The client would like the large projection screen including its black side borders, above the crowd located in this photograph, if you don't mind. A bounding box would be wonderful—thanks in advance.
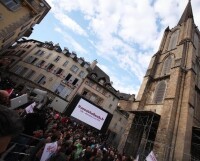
[66,95,112,132]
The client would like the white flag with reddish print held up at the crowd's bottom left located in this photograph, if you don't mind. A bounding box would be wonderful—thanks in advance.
[40,141,58,161]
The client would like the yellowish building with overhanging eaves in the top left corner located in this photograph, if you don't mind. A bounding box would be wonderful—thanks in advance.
[0,0,51,51]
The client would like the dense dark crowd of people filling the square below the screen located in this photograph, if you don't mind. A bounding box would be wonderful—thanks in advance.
[0,74,133,161]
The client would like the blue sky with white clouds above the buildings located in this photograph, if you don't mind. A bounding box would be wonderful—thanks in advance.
[29,0,200,95]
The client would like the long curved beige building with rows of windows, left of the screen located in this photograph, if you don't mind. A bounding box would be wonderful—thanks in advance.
[1,40,90,101]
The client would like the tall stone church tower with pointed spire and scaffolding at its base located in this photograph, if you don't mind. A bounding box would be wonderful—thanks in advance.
[120,1,200,161]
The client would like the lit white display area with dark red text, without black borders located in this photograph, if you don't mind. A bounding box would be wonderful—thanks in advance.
[71,98,108,130]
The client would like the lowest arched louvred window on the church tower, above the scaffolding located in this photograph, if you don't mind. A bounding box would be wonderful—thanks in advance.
[154,81,166,103]
